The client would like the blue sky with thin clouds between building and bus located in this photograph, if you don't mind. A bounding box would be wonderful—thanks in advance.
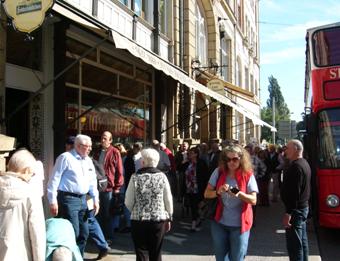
[259,0,340,121]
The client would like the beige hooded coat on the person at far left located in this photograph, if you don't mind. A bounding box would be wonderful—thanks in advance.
[0,172,46,261]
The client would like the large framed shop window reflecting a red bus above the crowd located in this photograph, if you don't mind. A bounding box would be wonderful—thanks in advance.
[65,32,153,146]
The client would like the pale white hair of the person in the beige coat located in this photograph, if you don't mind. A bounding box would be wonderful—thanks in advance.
[7,149,36,173]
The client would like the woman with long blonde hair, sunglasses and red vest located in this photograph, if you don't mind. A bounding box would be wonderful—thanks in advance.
[204,145,258,261]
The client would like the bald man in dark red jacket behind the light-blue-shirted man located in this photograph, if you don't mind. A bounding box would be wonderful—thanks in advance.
[93,131,124,240]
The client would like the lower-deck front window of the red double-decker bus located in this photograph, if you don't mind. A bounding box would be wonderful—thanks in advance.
[318,109,340,168]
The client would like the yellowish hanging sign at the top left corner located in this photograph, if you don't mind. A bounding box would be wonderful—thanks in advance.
[3,0,54,33]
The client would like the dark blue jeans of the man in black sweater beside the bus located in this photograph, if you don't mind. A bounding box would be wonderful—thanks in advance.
[286,207,309,261]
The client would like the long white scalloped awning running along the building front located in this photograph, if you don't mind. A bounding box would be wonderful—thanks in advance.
[53,3,276,131]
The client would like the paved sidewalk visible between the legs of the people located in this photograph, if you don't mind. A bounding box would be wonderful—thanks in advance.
[85,199,321,261]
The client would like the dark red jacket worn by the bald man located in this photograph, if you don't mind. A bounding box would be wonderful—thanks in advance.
[93,145,124,192]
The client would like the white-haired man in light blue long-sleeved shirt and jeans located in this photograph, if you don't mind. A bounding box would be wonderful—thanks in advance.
[47,134,99,254]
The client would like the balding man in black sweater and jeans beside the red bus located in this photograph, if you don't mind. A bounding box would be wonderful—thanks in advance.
[281,140,311,261]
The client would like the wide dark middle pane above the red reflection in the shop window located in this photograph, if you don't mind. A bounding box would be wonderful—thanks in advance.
[82,63,117,94]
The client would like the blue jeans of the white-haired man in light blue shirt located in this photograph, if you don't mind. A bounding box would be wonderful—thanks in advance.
[57,193,89,255]
